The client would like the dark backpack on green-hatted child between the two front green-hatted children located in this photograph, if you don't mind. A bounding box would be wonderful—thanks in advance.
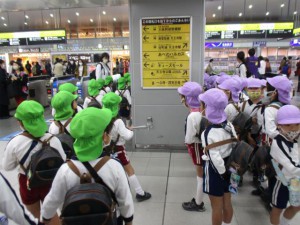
[54,118,75,159]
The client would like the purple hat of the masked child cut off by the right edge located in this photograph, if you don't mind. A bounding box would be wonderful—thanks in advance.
[276,105,300,125]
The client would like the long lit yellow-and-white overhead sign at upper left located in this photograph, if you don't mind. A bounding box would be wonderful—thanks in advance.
[0,30,67,46]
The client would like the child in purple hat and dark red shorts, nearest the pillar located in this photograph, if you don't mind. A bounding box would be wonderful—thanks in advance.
[178,82,205,212]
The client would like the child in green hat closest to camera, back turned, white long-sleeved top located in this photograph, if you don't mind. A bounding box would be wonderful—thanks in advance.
[41,107,134,225]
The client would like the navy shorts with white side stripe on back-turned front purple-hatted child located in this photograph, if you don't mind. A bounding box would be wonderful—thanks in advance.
[203,161,230,197]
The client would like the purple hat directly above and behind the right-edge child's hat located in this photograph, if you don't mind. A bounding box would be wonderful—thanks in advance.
[267,76,292,104]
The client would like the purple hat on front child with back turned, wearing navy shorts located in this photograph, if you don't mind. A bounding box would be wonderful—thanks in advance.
[198,88,228,124]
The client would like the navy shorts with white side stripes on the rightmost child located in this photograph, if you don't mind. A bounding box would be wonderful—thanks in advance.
[270,177,290,209]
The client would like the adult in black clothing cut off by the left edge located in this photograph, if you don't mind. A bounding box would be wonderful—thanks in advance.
[0,59,10,119]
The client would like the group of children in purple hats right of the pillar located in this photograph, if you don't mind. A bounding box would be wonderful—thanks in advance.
[178,73,300,225]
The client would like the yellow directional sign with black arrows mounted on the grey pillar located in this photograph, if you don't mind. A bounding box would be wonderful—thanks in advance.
[141,17,191,88]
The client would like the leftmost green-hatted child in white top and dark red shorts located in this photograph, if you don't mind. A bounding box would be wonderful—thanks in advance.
[2,101,66,224]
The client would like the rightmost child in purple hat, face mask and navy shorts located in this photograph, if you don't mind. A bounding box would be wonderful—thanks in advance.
[270,105,300,225]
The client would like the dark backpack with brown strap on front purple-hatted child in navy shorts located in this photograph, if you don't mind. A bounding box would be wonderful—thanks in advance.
[204,125,253,176]
